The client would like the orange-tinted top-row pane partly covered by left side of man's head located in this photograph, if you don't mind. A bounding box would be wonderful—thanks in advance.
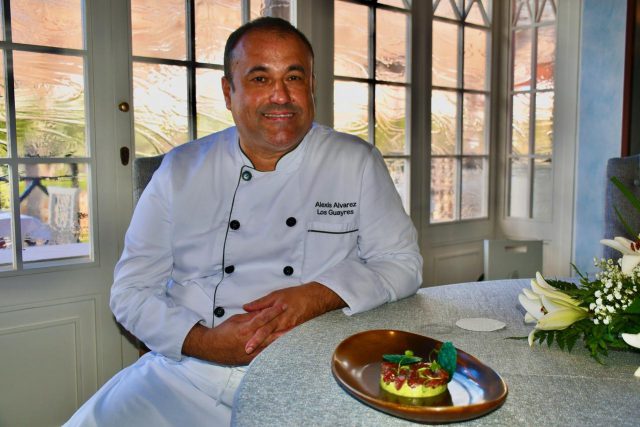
[195,0,242,64]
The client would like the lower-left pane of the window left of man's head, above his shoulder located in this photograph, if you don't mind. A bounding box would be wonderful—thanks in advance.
[133,63,189,157]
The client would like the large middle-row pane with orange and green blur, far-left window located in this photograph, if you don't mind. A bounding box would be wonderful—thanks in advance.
[13,51,88,157]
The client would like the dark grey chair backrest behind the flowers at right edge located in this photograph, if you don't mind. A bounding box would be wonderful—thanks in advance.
[602,155,640,259]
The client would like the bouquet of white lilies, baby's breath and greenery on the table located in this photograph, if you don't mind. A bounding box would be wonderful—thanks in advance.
[518,178,640,376]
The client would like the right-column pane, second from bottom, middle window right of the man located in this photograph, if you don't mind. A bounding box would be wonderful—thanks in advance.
[462,93,488,154]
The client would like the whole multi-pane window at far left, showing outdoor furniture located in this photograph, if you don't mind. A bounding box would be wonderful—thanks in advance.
[0,0,92,270]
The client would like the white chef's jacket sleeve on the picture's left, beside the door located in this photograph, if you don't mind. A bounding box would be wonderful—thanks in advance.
[110,156,203,360]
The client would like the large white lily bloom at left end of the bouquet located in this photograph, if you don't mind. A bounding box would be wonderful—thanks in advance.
[518,273,589,346]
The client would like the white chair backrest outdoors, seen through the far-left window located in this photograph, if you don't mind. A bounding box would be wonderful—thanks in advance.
[47,186,80,244]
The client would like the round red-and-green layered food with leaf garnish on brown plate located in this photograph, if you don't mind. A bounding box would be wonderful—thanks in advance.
[380,342,457,398]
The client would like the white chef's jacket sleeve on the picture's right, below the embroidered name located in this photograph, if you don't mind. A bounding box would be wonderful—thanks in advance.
[316,148,422,314]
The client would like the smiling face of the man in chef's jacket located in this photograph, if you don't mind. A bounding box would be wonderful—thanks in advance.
[222,30,315,166]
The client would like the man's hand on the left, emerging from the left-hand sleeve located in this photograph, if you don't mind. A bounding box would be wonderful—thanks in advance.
[182,303,288,365]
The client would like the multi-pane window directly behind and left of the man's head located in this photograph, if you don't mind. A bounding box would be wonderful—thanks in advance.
[131,0,290,156]
